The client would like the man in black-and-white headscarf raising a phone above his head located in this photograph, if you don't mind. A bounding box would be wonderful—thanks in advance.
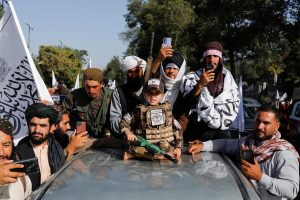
[151,47,186,108]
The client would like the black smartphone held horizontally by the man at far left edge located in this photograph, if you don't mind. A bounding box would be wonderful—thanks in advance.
[10,157,40,175]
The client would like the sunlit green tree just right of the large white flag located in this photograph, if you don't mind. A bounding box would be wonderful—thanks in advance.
[38,46,87,88]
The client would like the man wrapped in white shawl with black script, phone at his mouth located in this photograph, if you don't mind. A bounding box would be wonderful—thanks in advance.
[173,41,239,141]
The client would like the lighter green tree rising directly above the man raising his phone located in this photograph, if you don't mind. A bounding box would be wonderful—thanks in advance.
[122,0,194,60]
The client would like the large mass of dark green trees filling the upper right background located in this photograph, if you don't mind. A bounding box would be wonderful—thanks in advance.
[123,0,300,95]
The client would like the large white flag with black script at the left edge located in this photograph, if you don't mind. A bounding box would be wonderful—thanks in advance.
[0,0,53,140]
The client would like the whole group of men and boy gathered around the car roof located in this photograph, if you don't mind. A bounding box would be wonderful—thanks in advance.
[0,41,299,198]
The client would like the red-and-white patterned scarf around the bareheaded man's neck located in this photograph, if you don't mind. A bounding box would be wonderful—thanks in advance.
[245,131,300,162]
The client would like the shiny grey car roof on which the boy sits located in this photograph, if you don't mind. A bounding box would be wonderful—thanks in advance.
[29,148,261,200]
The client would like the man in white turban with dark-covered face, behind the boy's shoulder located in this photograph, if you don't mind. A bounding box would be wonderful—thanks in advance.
[109,56,146,138]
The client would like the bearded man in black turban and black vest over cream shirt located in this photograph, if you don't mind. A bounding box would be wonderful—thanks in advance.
[16,103,65,191]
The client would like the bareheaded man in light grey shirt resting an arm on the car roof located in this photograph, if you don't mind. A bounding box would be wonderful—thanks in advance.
[188,106,299,199]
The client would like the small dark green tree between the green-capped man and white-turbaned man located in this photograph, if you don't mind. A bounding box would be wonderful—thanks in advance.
[104,56,126,86]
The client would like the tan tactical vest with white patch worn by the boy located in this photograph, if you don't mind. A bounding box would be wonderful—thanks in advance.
[135,103,174,144]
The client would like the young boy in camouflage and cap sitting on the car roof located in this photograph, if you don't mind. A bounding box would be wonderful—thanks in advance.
[121,79,183,160]
